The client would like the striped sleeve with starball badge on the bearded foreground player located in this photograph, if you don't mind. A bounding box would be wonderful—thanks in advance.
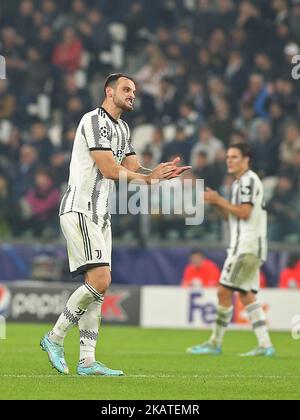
[81,115,112,152]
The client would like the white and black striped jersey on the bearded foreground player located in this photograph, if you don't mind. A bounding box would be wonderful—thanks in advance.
[60,108,135,227]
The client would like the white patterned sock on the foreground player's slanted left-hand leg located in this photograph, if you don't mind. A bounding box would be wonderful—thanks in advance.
[49,283,103,346]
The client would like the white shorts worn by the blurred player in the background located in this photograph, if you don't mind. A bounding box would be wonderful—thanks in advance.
[220,254,263,293]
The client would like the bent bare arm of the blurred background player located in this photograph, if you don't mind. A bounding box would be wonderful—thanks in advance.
[204,188,253,220]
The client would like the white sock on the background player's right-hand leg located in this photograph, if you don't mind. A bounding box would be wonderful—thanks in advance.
[246,302,272,348]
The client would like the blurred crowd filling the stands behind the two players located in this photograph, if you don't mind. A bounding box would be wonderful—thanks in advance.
[0,0,300,243]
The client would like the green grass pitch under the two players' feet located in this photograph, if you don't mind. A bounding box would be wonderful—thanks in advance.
[0,324,300,400]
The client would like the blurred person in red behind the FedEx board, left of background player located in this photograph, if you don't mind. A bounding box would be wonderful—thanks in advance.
[181,249,221,287]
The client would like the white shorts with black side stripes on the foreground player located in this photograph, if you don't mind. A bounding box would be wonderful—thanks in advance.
[60,212,112,277]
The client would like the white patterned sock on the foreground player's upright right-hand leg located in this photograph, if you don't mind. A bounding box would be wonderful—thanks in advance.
[78,301,103,367]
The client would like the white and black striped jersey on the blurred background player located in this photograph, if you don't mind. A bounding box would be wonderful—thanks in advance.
[229,171,268,261]
